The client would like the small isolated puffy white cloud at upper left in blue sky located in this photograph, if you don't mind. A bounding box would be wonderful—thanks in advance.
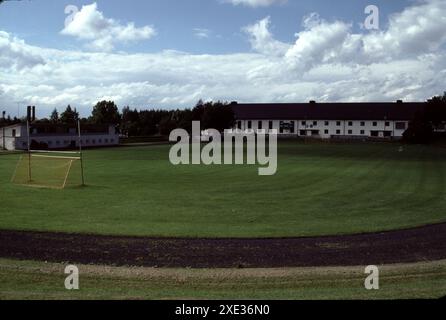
[61,3,156,51]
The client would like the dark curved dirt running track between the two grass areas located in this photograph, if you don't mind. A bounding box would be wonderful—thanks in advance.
[0,223,446,268]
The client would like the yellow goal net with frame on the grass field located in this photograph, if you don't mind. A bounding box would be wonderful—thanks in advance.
[11,151,82,189]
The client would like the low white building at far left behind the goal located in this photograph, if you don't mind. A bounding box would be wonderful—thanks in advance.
[0,123,119,151]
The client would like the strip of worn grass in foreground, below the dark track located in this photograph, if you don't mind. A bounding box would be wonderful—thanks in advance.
[0,259,446,300]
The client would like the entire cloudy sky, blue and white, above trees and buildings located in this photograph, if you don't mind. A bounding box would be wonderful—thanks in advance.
[0,0,446,116]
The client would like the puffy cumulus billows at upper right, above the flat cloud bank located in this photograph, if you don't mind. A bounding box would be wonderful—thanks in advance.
[245,0,446,72]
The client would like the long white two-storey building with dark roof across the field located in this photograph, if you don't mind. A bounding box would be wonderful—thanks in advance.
[231,100,425,139]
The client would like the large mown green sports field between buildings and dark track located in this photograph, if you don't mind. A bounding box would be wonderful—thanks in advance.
[0,142,446,237]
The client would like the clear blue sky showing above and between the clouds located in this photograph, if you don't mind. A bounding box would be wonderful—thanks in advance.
[0,0,410,53]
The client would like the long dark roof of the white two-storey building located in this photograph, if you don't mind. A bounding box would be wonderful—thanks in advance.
[231,102,425,120]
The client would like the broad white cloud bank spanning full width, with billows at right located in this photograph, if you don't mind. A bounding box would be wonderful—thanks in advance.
[0,0,446,116]
